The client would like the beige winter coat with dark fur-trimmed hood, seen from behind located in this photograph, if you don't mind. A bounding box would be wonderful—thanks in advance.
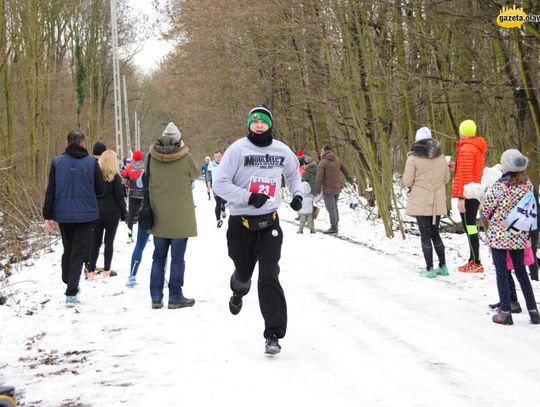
[403,139,450,219]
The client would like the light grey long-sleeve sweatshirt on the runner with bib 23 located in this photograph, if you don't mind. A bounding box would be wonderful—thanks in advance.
[212,137,303,216]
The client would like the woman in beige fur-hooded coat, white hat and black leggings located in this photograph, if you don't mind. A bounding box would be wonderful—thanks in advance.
[403,127,450,278]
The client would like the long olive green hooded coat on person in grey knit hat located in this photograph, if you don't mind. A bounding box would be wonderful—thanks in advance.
[145,136,199,239]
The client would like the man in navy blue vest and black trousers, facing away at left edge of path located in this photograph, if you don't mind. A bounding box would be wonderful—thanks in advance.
[43,131,105,307]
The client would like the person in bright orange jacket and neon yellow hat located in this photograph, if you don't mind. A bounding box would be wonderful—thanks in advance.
[452,120,488,273]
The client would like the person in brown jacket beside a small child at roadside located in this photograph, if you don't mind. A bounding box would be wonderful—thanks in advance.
[315,144,354,234]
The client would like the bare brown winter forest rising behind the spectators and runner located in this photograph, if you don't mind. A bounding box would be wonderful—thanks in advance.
[0,0,540,267]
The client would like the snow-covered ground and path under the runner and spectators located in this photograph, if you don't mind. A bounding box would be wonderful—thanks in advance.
[0,183,540,407]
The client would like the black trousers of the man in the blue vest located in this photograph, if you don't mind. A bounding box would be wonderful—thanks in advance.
[58,222,93,296]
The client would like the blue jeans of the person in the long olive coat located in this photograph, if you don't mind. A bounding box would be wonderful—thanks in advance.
[150,236,187,301]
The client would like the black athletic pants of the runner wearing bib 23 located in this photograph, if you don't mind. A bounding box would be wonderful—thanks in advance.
[227,216,287,338]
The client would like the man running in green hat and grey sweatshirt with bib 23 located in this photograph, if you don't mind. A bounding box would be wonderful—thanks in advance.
[213,105,303,354]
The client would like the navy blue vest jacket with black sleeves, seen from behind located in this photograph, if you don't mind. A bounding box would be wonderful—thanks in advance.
[43,144,104,223]
